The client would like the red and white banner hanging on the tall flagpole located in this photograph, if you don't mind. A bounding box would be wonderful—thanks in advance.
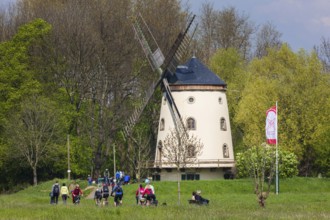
[266,106,277,144]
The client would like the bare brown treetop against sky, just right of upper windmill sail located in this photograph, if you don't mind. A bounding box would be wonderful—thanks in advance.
[197,3,255,62]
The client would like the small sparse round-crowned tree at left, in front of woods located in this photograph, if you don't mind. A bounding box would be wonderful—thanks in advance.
[7,96,60,185]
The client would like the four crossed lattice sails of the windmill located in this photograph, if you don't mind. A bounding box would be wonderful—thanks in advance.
[124,14,196,136]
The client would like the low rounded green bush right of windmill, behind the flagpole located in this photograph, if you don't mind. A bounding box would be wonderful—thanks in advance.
[235,146,298,178]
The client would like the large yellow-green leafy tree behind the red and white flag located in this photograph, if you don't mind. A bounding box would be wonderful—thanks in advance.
[234,45,330,175]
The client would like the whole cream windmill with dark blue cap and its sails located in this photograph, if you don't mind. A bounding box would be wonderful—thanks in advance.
[125,15,234,180]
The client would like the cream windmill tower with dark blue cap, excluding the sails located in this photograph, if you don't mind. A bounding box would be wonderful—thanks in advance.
[153,57,235,180]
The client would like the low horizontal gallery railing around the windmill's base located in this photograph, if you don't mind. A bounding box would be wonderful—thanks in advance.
[141,159,235,169]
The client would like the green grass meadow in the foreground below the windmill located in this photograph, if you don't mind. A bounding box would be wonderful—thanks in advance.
[0,178,330,220]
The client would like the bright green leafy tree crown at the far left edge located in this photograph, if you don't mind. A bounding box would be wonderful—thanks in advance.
[0,19,51,132]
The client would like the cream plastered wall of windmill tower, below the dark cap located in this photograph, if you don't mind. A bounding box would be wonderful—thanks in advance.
[155,88,234,167]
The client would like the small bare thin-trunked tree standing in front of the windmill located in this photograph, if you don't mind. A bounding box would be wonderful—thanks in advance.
[161,125,204,204]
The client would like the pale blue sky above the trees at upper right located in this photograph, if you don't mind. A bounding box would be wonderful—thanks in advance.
[187,0,330,51]
